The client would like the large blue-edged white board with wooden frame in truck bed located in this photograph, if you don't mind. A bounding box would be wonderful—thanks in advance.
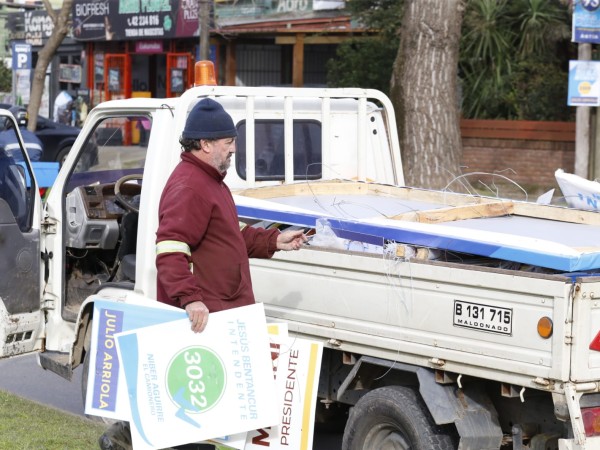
[235,183,600,272]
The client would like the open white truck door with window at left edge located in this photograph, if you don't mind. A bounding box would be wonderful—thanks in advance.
[0,110,43,358]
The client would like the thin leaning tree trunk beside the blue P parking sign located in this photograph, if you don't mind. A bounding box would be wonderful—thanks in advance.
[27,0,73,131]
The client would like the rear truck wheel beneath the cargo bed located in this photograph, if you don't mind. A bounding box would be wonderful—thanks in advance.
[342,386,457,450]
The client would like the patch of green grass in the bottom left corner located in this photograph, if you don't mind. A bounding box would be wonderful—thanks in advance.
[0,390,106,450]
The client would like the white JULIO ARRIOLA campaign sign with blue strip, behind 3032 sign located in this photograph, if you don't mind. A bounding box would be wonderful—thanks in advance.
[85,298,187,420]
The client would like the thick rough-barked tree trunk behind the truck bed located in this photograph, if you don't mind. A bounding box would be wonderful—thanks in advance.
[391,0,465,189]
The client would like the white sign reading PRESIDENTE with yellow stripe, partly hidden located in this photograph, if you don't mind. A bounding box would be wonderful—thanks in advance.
[244,337,323,450]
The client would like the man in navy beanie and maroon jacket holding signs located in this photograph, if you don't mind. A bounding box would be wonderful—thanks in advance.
[100,98,306,450]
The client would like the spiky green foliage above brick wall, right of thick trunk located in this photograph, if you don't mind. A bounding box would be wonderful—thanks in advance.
[460,0,570,120]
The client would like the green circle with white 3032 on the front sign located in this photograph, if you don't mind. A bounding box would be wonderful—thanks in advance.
[166,346,227,414]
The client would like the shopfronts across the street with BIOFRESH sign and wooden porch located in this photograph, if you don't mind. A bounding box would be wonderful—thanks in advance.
[4,0,364,117]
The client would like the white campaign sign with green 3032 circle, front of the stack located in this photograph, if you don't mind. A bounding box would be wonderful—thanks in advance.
[115,304,279,450]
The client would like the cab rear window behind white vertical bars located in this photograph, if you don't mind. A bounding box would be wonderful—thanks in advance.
[235,119,322,181]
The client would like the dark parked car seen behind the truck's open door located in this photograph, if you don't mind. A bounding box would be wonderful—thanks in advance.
[0,103,81,165]
